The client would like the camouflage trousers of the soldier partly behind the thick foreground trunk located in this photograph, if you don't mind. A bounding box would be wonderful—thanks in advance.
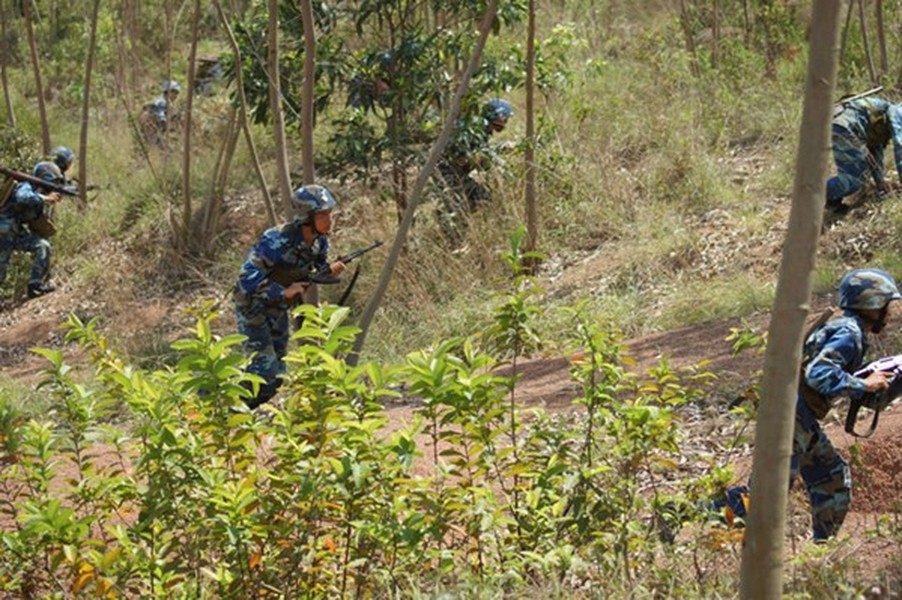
[714,398,852,541]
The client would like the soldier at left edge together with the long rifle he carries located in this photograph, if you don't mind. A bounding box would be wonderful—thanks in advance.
[0,161,77,298]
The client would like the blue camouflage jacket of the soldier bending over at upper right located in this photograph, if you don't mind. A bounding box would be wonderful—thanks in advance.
[833,97,902,184]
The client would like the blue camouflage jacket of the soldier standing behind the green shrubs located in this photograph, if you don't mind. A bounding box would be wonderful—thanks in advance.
[234,221,329,307]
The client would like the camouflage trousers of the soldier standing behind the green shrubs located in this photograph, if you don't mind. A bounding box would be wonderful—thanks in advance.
[235,301,290,402]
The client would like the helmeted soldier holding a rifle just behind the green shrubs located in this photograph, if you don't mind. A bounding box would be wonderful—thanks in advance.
[233,185,345,408]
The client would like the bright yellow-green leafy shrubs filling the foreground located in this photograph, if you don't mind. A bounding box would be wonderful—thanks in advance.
[0,302,756,598]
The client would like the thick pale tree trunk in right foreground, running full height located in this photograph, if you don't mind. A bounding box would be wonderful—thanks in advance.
[741,0,840,600]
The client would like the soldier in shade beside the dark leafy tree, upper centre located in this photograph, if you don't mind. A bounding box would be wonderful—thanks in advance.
[438,98,514,235]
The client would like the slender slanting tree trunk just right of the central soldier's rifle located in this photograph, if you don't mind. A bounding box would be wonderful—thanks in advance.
[348,0,498,365]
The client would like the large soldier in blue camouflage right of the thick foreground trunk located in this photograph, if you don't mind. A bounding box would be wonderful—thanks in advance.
[715,269,902,542]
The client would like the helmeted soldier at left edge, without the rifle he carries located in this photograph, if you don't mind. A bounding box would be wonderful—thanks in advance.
[0,162,63,298]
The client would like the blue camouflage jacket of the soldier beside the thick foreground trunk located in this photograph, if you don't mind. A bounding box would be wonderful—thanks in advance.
[802,311,868,408]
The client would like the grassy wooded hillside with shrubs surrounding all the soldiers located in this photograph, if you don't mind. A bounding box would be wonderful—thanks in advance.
[0,0,902,597]
